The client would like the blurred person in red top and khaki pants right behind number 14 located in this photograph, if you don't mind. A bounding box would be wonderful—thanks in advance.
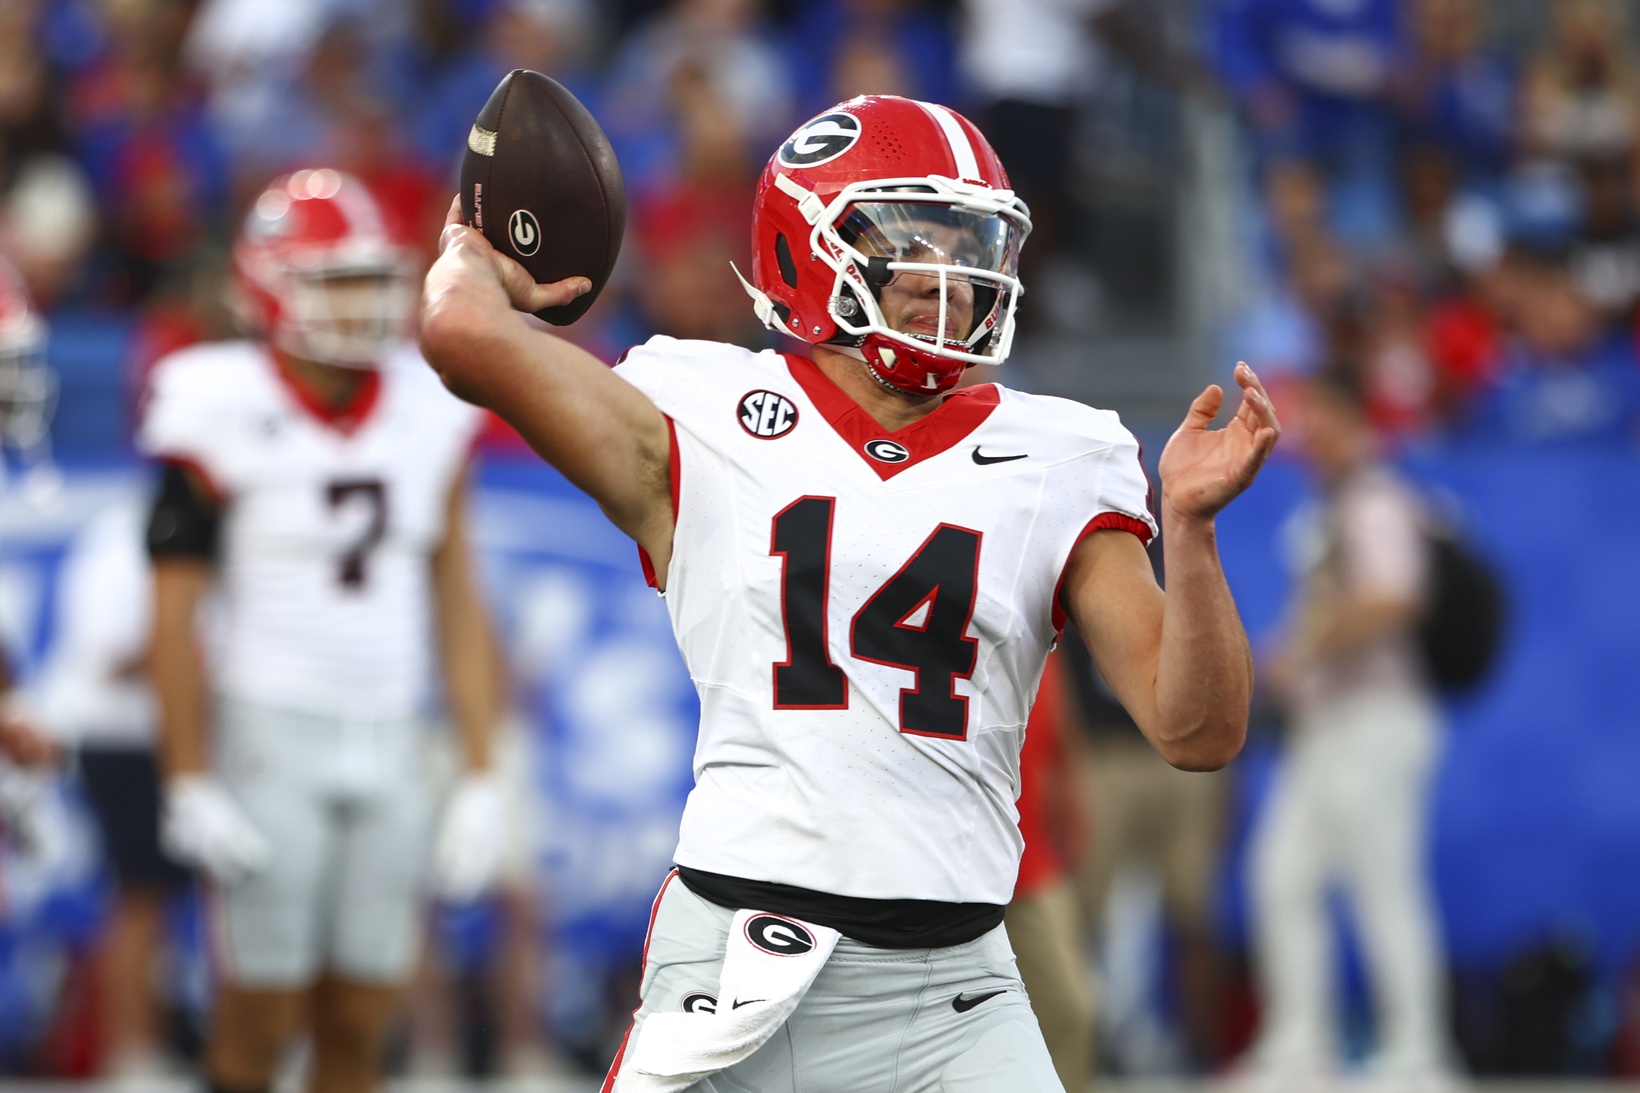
[1002,645,1095,1091]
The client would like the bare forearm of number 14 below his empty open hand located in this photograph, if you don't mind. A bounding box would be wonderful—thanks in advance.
[1151,509,1253,770]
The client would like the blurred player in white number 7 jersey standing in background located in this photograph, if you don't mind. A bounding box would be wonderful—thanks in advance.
[139,169,503,1093]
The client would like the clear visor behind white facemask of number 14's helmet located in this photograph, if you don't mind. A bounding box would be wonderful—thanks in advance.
[836,200,1023,348]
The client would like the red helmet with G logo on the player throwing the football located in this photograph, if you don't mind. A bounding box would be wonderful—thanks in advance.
[741,95,1030,394]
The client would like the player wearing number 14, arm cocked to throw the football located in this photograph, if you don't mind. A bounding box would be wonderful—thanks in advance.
[421,97,1279,1093]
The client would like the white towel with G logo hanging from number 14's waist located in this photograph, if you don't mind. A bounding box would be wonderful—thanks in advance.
[615,911,841,1093]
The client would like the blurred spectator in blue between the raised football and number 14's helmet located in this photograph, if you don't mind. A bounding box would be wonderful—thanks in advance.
[600,0,794,197]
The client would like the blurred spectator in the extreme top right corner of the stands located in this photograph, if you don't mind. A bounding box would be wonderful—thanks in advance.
[1520,0,1640,161]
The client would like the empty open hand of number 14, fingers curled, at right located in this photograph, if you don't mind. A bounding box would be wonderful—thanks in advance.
[1158,361,1281,519]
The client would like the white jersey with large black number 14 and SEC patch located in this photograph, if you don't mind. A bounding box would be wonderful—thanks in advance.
[617,338,1155,904]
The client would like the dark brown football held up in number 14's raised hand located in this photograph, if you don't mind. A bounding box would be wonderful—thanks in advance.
[461,69,626,327]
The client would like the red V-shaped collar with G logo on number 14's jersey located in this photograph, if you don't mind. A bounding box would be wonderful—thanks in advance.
[784,353,1002,481]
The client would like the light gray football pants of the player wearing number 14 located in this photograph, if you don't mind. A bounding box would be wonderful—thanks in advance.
[604,876,1064,1093]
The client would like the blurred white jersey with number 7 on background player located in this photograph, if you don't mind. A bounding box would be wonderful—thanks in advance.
[138,341,481,719]
